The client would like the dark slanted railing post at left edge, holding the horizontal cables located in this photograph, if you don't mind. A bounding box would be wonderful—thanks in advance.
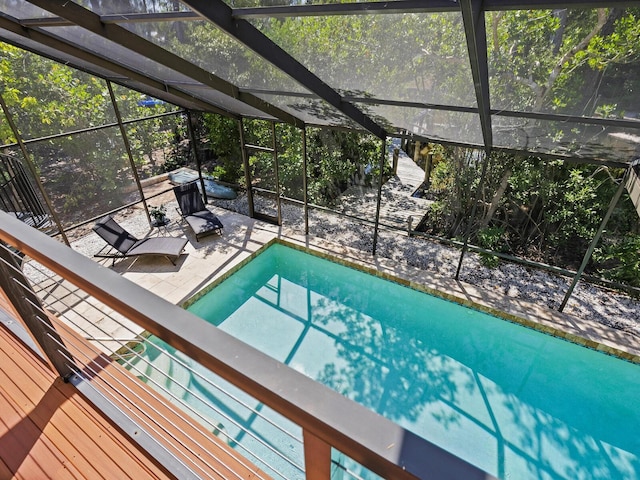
[0,244,74,381]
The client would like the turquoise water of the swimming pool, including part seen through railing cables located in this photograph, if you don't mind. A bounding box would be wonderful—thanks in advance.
[127,244,640,480]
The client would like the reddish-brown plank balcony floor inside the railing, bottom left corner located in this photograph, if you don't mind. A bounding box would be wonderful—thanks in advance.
[0,318,173,480]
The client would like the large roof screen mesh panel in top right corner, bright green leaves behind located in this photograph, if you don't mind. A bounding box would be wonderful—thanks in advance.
[485,8,640,122]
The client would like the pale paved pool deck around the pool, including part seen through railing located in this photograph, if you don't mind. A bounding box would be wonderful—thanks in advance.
[23,195,640,363]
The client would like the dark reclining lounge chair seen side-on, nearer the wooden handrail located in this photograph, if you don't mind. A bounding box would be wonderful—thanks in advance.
[93,215,188,265]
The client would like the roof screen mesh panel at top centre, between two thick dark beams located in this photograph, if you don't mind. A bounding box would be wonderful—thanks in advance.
[252,13,476,107]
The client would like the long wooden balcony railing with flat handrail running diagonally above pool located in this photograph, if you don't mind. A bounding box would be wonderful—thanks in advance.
[0,212,492,480]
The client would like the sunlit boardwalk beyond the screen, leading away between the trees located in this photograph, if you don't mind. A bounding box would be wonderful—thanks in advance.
[338,150,432,230]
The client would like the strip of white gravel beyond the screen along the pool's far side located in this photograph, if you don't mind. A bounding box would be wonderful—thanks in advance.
[204,191,640,336]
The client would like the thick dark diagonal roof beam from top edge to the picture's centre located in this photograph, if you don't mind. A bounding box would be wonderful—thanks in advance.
[183,0,386,139]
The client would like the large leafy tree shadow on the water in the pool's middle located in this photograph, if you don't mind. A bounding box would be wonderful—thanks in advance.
[314,299,473,423]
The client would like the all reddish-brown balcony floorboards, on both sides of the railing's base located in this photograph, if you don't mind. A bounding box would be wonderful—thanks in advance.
[0,298,269,480]
